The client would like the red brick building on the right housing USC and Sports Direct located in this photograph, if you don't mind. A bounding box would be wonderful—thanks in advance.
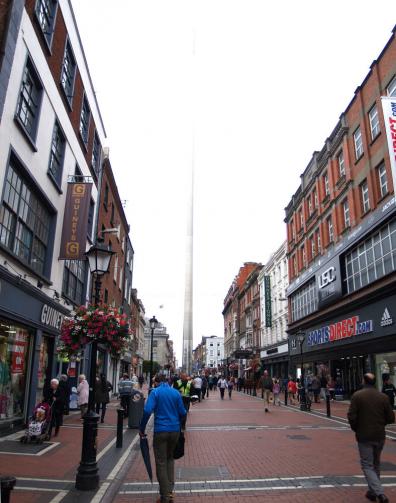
[285,24,396,394]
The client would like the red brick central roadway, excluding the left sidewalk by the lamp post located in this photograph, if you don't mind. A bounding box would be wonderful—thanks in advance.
[114,392,396,503]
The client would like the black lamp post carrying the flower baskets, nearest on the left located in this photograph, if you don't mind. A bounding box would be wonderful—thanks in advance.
[76,238,114,491]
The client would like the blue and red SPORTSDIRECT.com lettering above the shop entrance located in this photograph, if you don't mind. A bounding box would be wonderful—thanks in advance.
[307,316,374,346]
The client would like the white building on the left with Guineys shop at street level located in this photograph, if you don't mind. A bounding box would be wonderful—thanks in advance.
[0,0,106,430]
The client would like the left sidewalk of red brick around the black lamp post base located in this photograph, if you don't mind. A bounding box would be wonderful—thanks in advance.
[0,390,147,503]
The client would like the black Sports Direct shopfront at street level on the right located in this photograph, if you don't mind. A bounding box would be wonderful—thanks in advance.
[290,293,396,397]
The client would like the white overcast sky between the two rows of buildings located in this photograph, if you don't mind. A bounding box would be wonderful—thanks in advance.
[72,0,395,364]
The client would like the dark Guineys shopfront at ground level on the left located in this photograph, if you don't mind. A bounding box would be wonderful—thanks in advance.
[0,266,69,434]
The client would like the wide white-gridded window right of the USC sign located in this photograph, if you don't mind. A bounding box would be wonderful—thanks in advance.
[344,218,396,293]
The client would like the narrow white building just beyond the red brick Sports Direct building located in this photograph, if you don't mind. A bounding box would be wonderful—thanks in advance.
[258,242,289,377]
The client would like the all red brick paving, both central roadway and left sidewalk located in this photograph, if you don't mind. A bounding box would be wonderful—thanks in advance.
[0,392,396,503]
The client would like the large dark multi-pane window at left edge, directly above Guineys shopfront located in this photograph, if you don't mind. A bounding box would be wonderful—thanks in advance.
[0,157,53,275]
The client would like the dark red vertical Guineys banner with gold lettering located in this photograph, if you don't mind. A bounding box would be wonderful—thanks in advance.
[59,183,92,260]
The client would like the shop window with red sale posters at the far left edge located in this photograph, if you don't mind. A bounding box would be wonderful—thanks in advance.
[0,320,30,420]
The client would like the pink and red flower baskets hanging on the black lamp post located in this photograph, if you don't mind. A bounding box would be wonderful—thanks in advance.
[57,305,131,357]
